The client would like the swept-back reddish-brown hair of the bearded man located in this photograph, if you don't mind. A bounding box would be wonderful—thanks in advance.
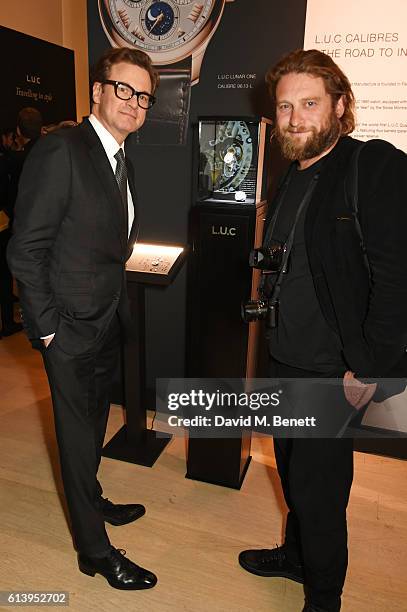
[266,49,355,134]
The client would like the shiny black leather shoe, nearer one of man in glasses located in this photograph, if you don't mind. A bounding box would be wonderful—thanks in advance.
[78,548,157,591]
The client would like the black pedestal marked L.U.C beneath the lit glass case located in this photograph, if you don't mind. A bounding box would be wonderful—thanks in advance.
[186,203,265,489]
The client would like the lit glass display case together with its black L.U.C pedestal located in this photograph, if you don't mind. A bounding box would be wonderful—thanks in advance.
[187,117,271,489]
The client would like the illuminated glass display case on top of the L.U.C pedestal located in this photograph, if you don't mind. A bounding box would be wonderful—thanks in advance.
[198,117,271,205]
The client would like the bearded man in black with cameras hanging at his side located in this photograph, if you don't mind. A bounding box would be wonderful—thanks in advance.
[239,50,407,612]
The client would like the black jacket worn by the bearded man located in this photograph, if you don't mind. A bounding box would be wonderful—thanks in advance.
[268,137,407,377]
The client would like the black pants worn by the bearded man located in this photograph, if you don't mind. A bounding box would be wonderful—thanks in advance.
[271,361,353,610]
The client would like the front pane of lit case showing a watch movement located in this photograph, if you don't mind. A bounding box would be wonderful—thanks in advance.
[199,120,258,202]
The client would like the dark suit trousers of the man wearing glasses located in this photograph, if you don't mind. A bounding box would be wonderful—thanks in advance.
[42,314,120,556]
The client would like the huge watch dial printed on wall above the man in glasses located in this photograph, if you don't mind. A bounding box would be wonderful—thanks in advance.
[103,0,219,54]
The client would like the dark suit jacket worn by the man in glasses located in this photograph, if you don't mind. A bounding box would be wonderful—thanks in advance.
[8,120,137,355]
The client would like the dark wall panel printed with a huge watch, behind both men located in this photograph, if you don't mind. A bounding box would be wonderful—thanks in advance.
[88,0,306,406]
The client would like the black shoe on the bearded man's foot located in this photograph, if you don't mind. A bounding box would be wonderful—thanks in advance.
[239,545,304,584]
